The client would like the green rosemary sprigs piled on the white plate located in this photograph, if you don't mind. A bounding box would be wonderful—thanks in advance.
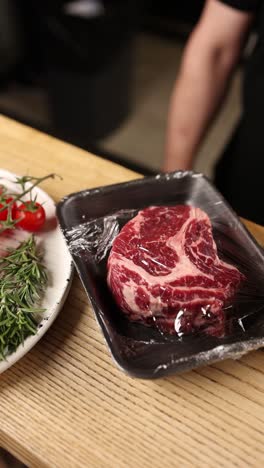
[0,236,47,360]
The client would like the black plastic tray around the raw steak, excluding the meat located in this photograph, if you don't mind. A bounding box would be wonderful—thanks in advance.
[57,172,264,378]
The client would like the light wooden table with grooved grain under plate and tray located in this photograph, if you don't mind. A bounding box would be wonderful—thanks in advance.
[0,117,264,468]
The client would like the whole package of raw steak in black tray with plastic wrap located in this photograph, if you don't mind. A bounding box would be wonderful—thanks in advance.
[58,172,264,378]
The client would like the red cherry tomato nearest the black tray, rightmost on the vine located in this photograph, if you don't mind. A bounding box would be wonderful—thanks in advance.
[13,200,46,232]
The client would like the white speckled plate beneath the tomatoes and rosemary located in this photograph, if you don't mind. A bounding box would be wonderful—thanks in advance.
[0,169,73,374]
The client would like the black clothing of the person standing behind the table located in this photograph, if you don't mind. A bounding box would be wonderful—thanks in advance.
[215,0,264,224]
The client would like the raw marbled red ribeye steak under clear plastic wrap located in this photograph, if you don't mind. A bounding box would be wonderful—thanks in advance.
[107,205,243,336]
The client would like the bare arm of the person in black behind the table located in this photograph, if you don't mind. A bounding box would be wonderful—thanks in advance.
[163,0,252,171]
